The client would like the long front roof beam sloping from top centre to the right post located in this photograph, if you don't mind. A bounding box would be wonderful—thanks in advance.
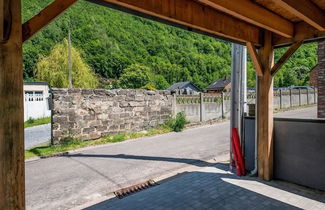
[88,0,260,46]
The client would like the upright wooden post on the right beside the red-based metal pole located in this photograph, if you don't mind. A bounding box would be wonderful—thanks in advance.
[257,31,274,180]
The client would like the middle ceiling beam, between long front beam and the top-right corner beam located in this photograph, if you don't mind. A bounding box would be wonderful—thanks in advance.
[198,0,293,38]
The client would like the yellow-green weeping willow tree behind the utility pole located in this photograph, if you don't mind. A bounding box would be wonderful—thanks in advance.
[36,40,98,88]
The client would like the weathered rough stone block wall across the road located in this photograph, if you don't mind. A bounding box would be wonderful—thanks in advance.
[52,89,173,144]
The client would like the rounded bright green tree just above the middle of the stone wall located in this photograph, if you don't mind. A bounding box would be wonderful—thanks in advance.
[118,64,151,89]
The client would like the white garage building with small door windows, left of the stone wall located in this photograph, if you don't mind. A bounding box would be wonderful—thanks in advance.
[24,82,51,121]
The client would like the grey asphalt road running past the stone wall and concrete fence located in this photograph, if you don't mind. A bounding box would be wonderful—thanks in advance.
[26,107,315,209]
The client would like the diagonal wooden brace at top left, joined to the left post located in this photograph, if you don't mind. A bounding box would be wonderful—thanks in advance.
[23,0,78,42]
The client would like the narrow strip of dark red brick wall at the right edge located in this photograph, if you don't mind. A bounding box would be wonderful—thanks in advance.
[317,41,325,118]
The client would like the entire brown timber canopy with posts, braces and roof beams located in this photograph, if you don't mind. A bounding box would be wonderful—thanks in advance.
[0,0,325,209]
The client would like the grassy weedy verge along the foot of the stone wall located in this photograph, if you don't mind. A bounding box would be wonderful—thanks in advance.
[25,125,172,159]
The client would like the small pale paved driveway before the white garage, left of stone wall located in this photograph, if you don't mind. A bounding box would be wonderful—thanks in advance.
[25,124,51,149]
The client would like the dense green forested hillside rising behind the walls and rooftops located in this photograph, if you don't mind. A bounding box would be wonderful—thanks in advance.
[23,0,316,88]
